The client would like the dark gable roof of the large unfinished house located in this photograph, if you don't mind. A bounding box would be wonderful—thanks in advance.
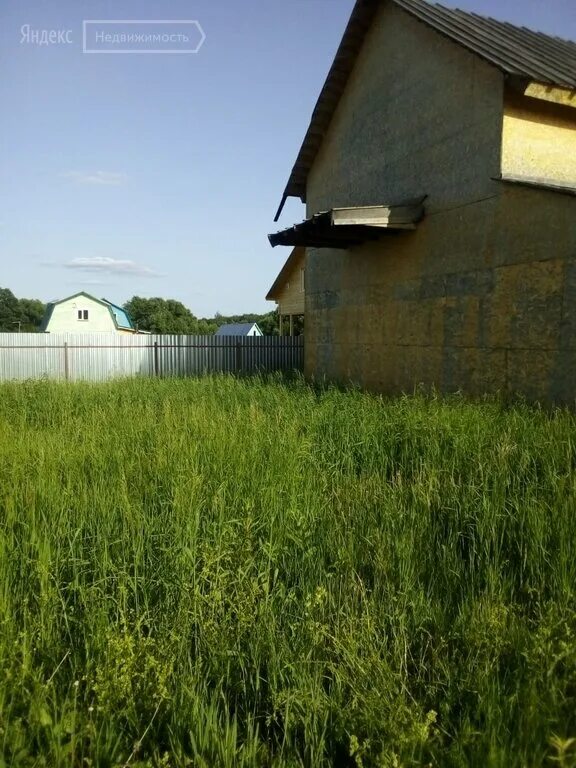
[274,0,576,221]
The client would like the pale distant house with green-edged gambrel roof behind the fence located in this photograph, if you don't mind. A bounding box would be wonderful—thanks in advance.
[41,291,143,334]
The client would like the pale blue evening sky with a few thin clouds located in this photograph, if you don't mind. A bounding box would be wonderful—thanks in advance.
[0,0,576,317]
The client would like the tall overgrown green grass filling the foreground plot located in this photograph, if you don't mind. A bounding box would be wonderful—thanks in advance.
[0,377,576,768]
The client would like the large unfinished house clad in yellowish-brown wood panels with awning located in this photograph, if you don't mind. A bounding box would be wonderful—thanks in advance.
[270,0,576,403]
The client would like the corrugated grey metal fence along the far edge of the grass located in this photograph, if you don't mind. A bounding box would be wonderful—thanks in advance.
[0,333,304,381]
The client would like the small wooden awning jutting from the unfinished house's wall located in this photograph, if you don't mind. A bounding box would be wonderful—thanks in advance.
[268,197,425,248]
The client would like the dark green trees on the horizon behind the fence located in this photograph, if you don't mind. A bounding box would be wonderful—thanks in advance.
[0,288,278,336]
